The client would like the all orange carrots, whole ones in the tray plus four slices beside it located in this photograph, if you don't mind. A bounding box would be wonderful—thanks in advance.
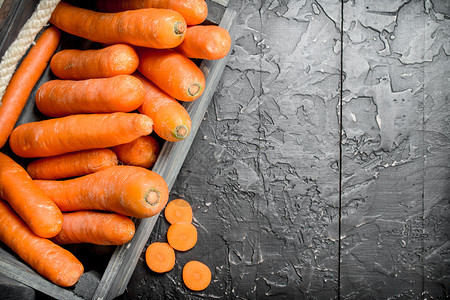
[0,0,231,290]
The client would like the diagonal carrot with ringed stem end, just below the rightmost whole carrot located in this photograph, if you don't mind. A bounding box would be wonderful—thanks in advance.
[137,48,205,101]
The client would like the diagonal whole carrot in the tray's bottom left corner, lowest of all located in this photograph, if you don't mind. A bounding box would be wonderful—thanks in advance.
[0,200,84,287]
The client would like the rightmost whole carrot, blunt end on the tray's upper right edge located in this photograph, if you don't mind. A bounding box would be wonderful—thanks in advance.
[175,25,231,60]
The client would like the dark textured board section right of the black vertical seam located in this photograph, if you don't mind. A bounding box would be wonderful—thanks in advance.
[341,0,450,299]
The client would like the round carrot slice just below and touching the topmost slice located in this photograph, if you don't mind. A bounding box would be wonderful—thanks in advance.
[167,223,197,251]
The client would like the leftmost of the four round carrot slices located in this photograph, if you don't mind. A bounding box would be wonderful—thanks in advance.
[145,242,175,273]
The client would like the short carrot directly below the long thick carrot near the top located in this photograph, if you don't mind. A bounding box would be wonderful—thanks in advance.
[50,44,139,80]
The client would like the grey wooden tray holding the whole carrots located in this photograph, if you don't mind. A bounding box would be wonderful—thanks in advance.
[0,0,236,299]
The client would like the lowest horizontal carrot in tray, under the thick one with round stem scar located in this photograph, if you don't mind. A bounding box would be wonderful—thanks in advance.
[52,211,135,245]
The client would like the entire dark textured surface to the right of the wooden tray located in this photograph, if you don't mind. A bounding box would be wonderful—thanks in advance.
[121,0,450,299]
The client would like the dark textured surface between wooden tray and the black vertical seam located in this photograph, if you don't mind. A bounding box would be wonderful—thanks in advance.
[121,1,340,299]
